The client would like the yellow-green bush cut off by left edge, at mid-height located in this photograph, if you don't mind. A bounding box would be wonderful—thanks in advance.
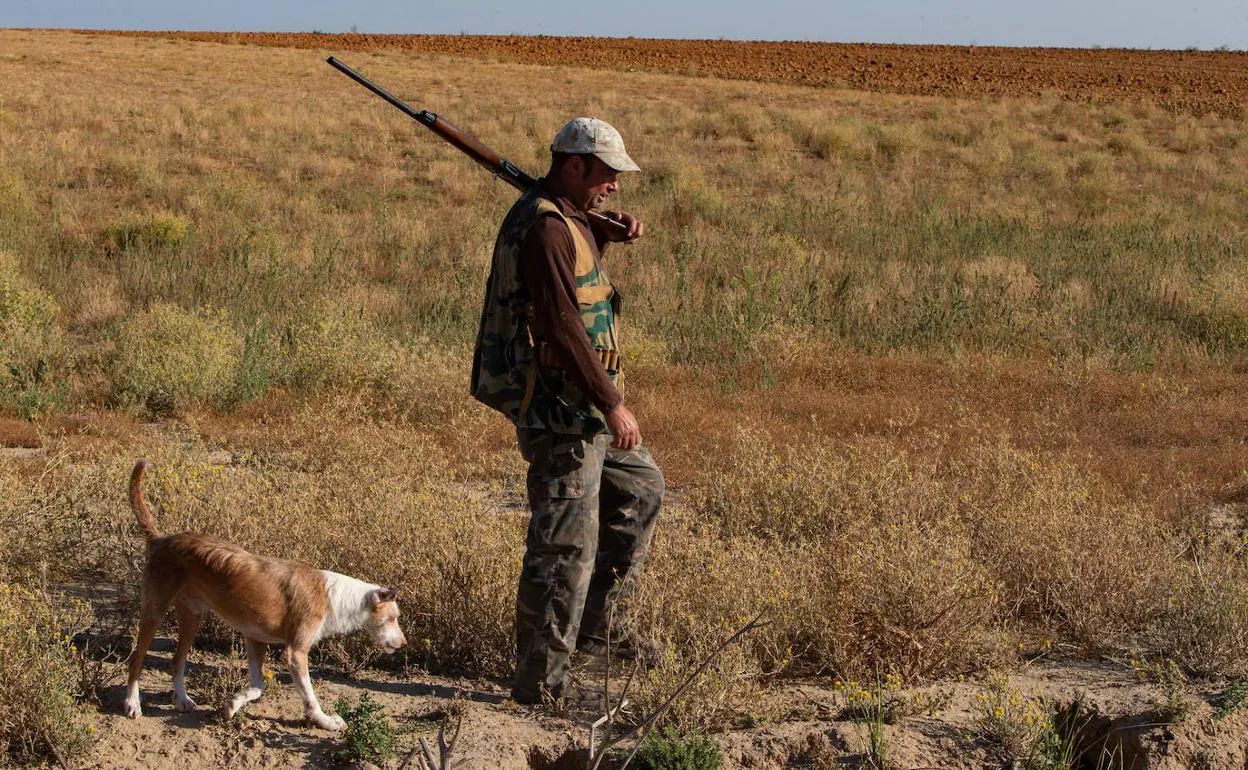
[0,251,71,418]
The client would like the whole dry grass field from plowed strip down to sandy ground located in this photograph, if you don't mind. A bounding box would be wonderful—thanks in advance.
[0,31,1248,738]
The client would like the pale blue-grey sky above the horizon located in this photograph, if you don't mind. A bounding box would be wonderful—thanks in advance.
[0,0,1248,50]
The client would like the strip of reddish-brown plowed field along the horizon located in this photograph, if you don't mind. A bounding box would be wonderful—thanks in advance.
[80,31,1248,115]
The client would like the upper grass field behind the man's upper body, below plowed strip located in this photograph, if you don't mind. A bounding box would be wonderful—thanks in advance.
[0,32,1248,389]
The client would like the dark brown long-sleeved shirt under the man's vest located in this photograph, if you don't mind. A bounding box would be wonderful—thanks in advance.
[519,180,622,414]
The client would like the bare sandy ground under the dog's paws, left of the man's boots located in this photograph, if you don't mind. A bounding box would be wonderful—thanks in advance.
[85,639,577,769]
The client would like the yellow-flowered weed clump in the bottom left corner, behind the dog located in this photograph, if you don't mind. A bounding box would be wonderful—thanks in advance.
[0,582,95,768]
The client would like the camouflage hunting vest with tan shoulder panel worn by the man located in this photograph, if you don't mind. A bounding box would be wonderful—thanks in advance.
[472,190,619,436]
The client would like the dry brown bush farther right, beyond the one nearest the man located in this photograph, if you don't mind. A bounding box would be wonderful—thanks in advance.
[953,443,1183,651]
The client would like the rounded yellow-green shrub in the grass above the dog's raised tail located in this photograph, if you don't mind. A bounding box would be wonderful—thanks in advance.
[111,305,241,414]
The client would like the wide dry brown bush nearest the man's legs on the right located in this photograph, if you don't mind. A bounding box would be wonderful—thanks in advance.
[681,432,1002,676]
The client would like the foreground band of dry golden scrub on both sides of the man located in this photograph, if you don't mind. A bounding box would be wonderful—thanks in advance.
[0,416,1248,726]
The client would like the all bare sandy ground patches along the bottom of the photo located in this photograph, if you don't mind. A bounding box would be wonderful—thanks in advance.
[85,639,1248,770]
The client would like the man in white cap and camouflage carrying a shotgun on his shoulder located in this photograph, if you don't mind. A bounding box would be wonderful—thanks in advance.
[472,117,663,703]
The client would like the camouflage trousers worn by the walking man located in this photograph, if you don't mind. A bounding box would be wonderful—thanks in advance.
[512,428,663,703]
